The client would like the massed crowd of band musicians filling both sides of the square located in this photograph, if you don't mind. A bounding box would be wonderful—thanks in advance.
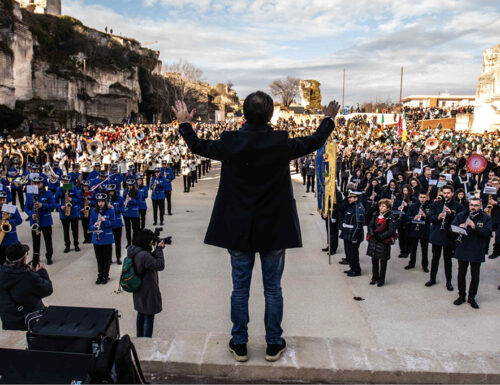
[0,109,500,335]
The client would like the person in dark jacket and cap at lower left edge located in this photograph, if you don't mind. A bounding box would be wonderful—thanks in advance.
[0,243,52,330]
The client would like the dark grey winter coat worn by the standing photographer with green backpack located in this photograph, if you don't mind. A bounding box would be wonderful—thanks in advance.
[127,245,165,315]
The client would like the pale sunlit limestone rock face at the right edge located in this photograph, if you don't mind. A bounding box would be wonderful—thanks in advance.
[472,44,500,132]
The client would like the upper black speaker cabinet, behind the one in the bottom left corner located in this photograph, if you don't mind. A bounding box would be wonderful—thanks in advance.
[26,306,120,354]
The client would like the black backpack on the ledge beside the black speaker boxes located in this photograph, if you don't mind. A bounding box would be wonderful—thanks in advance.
[90,334,149,384]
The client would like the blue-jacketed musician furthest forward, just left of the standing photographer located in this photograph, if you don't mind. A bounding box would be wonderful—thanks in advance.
[90,193,115,285]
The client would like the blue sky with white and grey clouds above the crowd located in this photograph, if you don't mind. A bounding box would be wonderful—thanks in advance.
[62,0,500,105]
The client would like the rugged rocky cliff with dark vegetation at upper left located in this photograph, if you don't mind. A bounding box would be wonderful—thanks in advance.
[0,0,162,128]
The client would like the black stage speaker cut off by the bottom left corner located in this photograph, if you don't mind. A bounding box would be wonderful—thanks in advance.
[0,349,94,384]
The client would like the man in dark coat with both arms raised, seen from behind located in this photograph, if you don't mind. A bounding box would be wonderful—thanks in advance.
[173,91,339,361]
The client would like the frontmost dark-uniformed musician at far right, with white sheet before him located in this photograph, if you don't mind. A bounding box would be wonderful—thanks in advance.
[452,197,492,309]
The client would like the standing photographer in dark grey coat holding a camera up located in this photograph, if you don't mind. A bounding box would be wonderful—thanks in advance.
[127,229,170,338]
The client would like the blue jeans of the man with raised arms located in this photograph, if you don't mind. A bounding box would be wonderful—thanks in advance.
[228,250,285,344]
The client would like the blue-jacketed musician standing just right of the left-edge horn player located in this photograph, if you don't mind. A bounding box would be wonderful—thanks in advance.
[24,176,56,265]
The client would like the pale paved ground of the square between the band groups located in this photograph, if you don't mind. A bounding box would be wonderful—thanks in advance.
[6,163,500,351]
